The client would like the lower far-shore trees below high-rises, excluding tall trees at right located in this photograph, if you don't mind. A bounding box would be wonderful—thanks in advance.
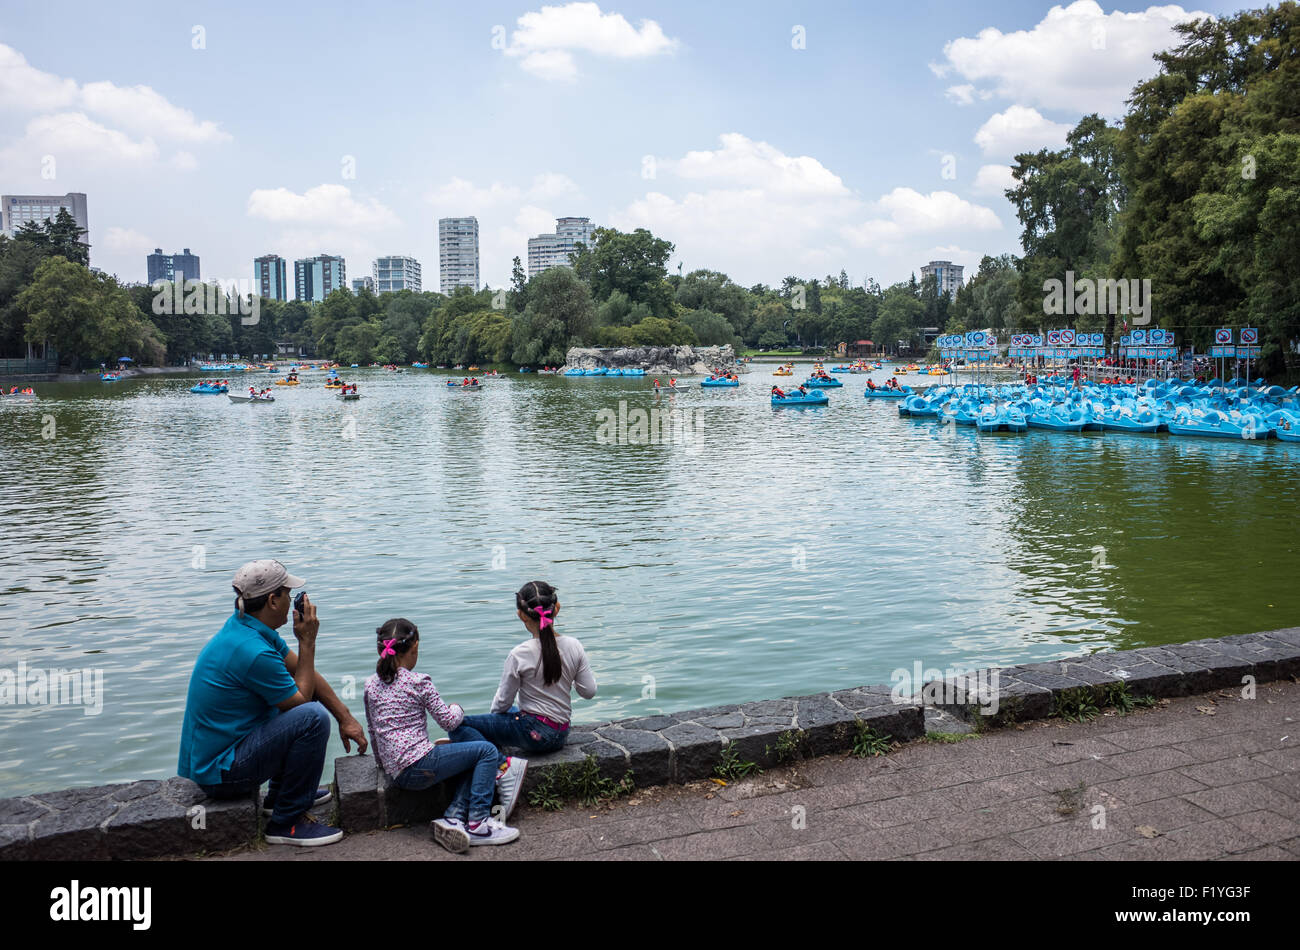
[0,212,949,366]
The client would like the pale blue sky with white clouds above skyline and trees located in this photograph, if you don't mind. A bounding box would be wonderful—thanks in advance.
[0,0,1236,290]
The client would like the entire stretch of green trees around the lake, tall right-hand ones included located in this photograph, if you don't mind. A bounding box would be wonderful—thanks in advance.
[0,7,1300,374]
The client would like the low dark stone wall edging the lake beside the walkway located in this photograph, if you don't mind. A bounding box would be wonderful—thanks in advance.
[0,628,1300,860]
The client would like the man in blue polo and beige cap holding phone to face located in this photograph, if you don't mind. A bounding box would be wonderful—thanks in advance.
[177,560,367,846]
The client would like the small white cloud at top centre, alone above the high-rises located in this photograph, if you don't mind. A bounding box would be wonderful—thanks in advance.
[506,3,680,79]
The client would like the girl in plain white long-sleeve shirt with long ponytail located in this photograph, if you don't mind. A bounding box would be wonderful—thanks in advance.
[447,581,595,754]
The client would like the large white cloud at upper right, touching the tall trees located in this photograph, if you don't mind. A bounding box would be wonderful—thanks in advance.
[931,0,1210,117]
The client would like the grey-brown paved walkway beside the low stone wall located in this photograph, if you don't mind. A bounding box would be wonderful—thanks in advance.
[208,681,1300,862]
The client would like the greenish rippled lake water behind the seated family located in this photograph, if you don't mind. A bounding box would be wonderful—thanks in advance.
[0,366,1300,795]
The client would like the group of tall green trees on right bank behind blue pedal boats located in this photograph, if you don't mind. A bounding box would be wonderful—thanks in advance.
[946,3,1300,376]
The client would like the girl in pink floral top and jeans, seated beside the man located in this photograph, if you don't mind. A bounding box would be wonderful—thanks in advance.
[365,617,521,853]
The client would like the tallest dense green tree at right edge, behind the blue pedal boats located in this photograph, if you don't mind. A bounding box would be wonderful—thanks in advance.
[1118,3,1300,373]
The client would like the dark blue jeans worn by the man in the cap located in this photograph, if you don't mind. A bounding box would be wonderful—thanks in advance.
[199,703,330,825]
